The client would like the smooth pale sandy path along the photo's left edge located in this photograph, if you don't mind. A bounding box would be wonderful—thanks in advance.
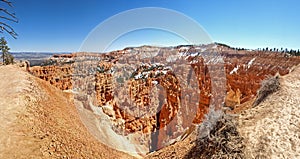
[0,66,40,158]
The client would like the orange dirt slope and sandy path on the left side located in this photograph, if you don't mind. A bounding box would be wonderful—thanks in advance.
[0,66,132,158]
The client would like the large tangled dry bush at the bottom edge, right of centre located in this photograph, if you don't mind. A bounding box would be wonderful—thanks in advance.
[184,111,244,159]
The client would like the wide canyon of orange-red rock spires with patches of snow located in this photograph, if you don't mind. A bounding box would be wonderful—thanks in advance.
[29,44,300,152]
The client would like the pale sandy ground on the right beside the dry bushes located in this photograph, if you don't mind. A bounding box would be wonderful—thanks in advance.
[239,66,300,158]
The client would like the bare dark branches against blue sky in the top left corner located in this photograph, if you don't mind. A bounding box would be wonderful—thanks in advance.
[0,0,18,39]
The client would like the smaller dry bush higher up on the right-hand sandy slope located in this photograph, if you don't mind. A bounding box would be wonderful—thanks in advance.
[253,75,280,107]
